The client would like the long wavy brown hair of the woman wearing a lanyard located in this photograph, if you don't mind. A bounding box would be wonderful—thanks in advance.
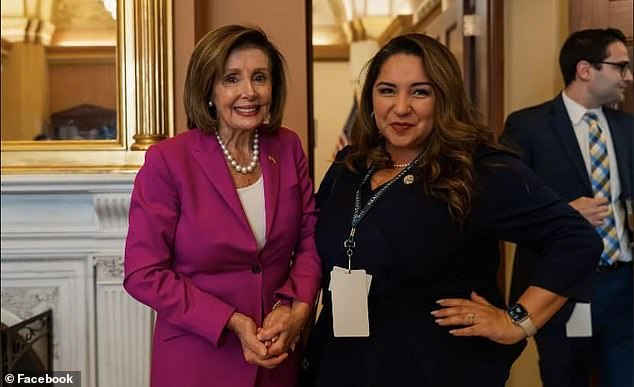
[345,33,503,223]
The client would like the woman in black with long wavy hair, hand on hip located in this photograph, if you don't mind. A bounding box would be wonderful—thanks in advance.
[304,34,602,387]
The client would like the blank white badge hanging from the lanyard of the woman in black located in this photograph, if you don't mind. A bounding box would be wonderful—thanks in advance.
[328,266,372,337]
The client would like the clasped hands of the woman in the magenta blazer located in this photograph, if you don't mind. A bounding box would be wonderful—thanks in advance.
[227,301,310,369]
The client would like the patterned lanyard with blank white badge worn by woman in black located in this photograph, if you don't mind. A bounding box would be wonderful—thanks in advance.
[328,153,422,337]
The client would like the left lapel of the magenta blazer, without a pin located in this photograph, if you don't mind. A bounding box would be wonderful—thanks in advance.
[193,129,251,231]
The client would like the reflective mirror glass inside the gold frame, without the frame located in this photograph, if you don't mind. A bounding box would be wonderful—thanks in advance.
[1,0,121,141]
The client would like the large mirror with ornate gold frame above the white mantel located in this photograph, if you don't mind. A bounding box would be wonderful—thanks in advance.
[2,0,173,174]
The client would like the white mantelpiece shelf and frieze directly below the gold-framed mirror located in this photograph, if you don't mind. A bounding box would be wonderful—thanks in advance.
[0,174,134,249]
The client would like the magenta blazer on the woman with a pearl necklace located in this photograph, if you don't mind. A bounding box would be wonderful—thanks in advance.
[124,128,321,387]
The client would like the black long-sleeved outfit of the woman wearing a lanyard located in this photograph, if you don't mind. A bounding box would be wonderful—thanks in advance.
[309,148,602,387]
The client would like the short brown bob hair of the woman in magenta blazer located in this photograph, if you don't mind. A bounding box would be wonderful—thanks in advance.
[183,25,286,133]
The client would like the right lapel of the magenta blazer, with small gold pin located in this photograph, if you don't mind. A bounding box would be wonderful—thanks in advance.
[260,133,281,239]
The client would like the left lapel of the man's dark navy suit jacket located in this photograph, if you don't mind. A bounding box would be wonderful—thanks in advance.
[549,95,593,196]
